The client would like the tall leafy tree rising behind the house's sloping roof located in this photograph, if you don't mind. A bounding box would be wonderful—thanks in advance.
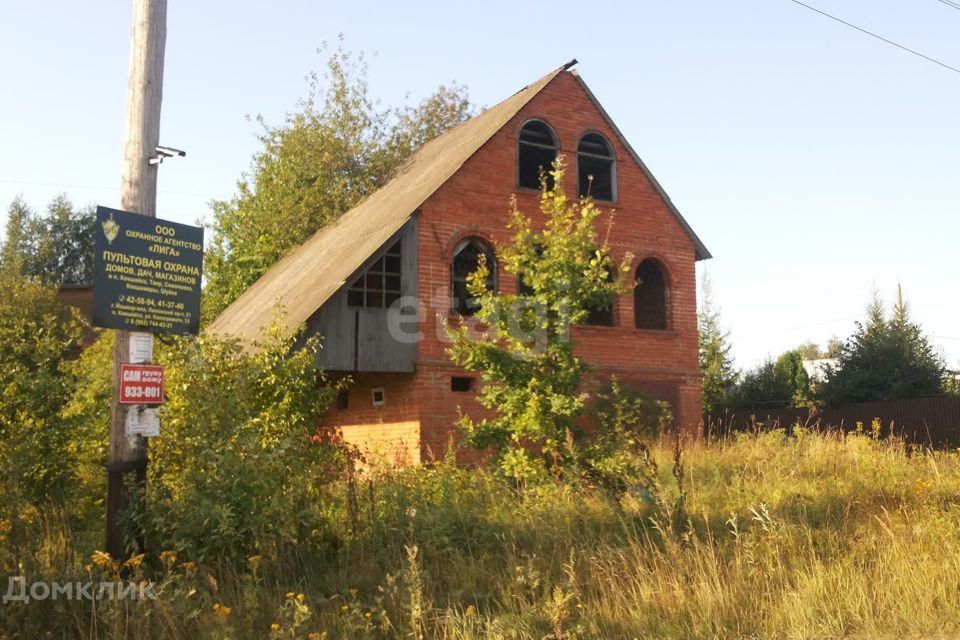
[204,43,470,319]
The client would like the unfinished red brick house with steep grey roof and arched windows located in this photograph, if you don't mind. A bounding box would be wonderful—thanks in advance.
[209,61,710,461]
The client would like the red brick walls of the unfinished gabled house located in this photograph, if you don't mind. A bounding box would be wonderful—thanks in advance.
[322,73,700,457]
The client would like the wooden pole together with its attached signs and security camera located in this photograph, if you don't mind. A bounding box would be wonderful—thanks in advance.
[92,0,203,559]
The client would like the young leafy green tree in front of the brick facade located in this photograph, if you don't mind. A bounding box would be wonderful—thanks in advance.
[449,160,629,478]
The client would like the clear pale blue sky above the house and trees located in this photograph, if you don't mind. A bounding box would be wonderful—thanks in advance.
[0,0,960,368]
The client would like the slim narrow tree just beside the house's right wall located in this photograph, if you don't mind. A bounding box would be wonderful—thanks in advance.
[697,272,738,413]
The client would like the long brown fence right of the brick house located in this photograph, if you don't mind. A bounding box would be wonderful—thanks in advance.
[704,396,960,448]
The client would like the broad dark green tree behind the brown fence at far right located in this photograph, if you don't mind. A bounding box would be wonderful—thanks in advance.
[820,290,946,405]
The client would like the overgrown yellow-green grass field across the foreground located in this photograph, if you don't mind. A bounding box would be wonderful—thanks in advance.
[0,424,960,640]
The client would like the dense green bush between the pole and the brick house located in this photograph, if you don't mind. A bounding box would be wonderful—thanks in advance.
[136,324,345,560]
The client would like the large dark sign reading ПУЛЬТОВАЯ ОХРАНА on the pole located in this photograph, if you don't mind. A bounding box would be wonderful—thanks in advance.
[93,207,203,334]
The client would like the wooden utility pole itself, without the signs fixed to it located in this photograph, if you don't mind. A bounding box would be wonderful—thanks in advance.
[107,0,167,559]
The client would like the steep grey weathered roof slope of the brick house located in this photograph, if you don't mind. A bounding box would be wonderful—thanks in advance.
[207,61,575,342]
